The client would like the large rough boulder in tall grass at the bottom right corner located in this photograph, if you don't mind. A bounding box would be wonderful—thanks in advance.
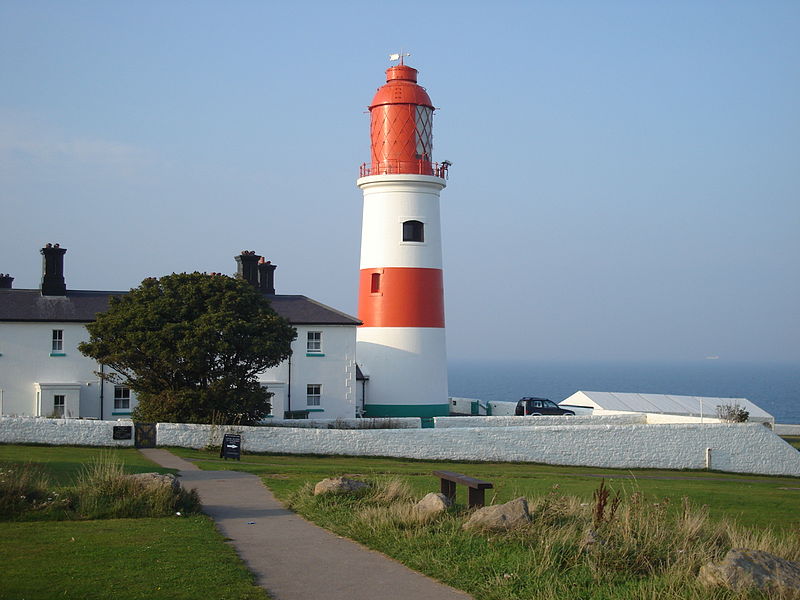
[697,548,800,598]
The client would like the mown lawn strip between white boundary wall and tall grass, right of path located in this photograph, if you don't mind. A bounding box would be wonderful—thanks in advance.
[171,448,800,529]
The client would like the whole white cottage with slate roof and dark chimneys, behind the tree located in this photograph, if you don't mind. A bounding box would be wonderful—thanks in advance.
[0,244,360,420]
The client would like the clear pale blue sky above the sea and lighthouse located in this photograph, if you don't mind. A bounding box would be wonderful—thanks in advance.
[0,0,800,362]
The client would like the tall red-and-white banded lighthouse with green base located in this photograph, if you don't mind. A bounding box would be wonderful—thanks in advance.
[356,55,449,417]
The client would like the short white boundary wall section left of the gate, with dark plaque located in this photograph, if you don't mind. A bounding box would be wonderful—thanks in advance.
[0,417,133,446]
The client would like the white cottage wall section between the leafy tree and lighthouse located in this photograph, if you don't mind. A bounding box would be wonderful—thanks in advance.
[259,325,356,419]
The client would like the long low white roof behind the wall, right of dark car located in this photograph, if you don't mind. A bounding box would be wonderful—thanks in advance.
[560,391,774,421]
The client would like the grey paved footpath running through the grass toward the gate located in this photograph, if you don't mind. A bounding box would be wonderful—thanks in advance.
[141,449,470,600]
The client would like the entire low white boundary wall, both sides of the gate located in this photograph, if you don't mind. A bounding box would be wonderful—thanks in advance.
[0,417,800,477]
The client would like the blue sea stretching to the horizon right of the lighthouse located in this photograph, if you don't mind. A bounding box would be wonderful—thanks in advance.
[448,360,800,424]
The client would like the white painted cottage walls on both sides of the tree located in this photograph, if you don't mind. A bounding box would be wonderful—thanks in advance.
[0,324,356,420]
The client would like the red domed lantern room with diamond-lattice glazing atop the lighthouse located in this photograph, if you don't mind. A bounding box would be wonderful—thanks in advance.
[362,63,443,176]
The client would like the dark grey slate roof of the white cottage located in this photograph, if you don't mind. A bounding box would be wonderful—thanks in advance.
[0,289,361,325]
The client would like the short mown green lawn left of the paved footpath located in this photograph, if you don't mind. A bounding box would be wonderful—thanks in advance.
[0,445,268,600]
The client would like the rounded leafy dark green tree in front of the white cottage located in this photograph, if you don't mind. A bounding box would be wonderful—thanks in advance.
[78,273,297,425]
